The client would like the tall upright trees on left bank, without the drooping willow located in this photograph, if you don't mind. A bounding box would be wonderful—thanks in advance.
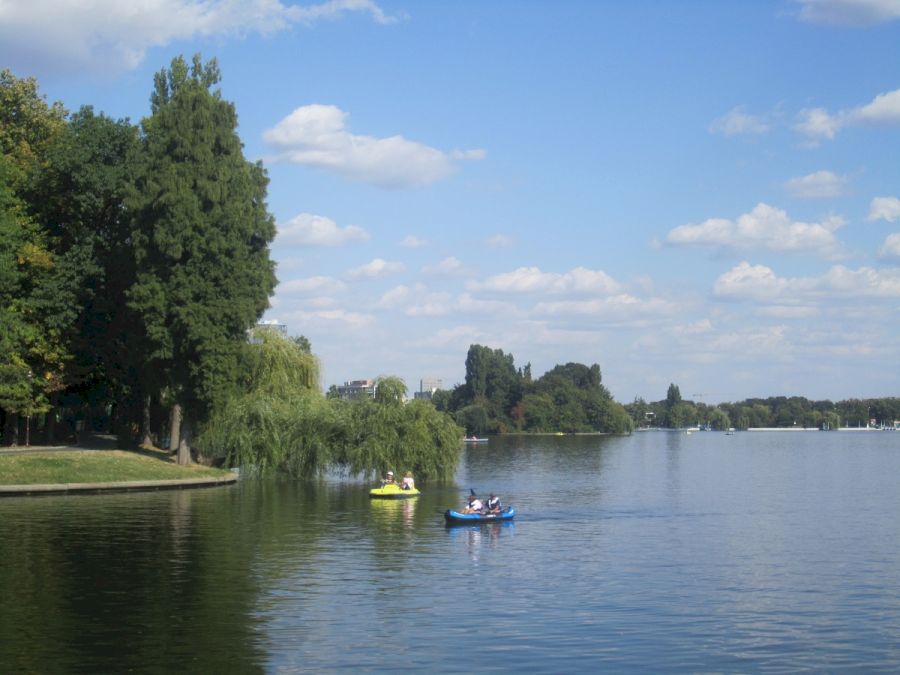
[0,56,275,462]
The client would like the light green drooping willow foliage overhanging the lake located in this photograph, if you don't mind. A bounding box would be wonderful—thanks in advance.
[196,329,462,481]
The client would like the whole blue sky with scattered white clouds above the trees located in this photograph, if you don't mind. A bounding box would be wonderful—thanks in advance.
[0,0,900,403]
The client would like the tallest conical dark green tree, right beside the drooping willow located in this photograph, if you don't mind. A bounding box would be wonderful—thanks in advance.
[129,55,276,463]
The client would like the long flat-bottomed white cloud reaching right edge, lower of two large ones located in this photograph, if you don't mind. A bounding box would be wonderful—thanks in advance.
[713,261,900,304]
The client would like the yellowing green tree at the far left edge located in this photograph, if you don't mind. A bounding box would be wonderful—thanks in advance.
[0,70,67,443]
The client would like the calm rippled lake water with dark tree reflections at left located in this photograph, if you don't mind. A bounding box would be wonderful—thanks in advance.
[0,432,900,673]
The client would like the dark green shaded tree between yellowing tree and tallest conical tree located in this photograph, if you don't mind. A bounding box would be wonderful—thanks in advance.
[29,107,141,440]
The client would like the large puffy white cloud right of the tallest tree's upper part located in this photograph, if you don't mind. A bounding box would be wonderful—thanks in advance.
[263,104,486,188]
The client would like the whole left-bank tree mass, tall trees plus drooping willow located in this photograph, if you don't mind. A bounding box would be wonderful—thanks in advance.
[0,56,462,479]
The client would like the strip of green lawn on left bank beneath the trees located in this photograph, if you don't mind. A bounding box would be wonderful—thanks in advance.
[0,450,236,485]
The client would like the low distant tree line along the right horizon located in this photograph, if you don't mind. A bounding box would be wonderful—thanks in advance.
[625,384,900,430]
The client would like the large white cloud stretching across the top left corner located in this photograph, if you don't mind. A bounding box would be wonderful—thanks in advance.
[0,0,396,73]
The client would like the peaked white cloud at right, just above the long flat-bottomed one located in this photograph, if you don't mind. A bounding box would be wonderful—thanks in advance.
[666,203,844,257]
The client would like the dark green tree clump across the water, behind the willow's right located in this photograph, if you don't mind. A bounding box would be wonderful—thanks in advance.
[433,345,632,434]
